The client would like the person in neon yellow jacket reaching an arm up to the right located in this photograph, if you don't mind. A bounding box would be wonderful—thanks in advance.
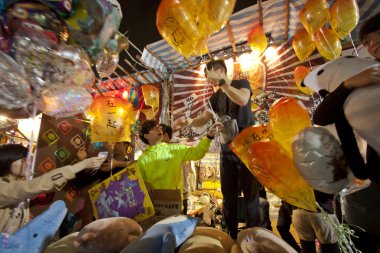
[137,120,221,199]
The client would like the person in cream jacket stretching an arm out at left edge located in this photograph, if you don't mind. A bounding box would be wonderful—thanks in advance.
[0,144,104,234]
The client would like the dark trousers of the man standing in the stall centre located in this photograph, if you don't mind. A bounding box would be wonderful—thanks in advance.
[220,144,261,239]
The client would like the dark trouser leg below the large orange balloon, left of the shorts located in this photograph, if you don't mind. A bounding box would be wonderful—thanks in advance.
[277,201,301,253]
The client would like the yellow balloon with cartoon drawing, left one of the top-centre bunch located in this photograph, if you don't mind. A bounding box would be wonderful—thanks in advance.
[156,0,200,58]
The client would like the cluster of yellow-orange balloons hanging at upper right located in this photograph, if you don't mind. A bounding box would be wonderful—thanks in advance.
[292,0,360,95]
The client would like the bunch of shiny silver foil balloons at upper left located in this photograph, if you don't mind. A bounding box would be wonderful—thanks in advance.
[0,0,124,118]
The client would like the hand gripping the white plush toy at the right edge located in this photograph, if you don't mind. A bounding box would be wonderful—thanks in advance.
[343,64,380,89]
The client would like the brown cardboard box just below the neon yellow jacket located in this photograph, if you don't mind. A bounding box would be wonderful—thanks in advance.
[139,189,182,231]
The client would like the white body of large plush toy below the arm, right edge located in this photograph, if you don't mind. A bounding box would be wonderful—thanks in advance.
[344,83,380,156]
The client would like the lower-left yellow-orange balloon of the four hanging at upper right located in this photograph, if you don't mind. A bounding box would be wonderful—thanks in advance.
[292,29,315,61]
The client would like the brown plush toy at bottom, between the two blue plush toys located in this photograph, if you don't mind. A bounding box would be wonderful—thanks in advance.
[74,217,142,253]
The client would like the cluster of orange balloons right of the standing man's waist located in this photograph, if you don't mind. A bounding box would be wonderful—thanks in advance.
[230,97,317,211]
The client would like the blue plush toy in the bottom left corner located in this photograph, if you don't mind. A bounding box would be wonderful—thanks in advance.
[0,200,67,253]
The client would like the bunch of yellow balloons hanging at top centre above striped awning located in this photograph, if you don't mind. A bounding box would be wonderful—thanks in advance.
[156,0,236,58]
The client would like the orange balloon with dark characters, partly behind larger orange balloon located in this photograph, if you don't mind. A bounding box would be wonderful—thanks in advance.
[230,125,272,167]
